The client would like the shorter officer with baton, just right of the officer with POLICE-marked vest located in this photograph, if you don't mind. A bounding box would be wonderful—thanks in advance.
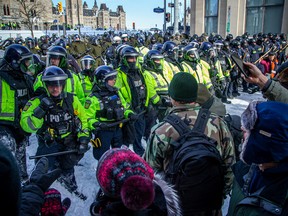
[84,65,137,160]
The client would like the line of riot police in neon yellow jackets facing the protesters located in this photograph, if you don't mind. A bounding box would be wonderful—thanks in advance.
[0,29,285,190]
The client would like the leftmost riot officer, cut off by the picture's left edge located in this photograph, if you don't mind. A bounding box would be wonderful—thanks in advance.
[0,44,33,181]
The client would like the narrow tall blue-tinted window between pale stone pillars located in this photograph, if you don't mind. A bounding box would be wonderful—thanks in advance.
[205,0,218,34]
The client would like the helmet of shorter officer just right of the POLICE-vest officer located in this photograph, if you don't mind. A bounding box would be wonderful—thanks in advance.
[94,65,117,89]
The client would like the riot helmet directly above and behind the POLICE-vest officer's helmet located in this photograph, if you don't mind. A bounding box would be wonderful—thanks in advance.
[46,46,68,69]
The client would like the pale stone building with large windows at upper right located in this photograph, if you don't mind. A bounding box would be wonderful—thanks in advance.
[190,0,288,36]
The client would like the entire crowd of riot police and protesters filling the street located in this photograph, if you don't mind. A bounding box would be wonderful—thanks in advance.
[0,29,288,216]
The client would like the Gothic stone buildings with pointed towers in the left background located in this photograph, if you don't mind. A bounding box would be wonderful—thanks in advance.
[0,0,126,30]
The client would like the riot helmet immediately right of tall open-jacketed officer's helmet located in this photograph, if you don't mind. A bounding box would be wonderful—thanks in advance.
[144,50,164,73]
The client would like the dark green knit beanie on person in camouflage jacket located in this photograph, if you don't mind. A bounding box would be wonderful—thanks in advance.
[168,72,198,103]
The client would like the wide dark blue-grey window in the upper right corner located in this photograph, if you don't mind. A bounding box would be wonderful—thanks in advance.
[246,0,284,34]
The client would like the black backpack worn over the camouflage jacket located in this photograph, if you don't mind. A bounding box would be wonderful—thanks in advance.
[164,108,224,215]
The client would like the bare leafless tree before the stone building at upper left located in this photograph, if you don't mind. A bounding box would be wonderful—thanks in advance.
[17,0,45,38]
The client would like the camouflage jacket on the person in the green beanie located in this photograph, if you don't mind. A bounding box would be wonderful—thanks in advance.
[144,103,235,195]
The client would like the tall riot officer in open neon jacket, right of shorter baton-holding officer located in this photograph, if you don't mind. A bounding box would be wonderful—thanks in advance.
[115,46,160,155]
